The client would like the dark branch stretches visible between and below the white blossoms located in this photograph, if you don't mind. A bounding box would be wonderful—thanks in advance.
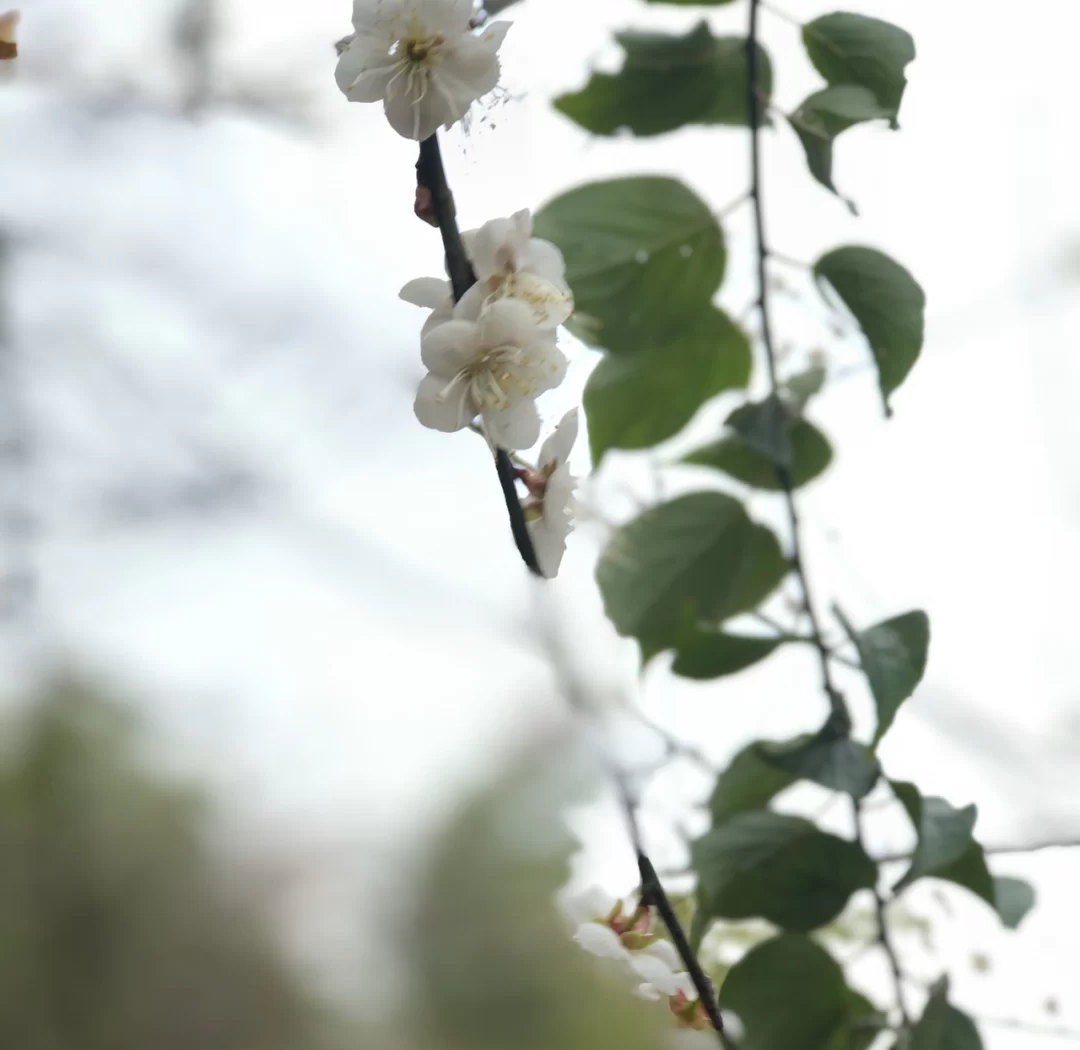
[416,135,543,577]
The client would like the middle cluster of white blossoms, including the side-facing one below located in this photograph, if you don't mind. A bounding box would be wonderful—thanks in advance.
[401,211,578,577]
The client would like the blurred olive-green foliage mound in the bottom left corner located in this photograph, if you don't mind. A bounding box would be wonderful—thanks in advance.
[0,681,345,1050]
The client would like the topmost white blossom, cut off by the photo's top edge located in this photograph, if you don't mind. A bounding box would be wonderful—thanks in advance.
[335,0,510,142]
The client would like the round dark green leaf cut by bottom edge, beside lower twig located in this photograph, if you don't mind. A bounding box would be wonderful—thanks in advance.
[720,934,854,1050]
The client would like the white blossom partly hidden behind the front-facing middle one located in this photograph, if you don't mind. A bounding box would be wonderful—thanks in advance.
[400,210,573,332]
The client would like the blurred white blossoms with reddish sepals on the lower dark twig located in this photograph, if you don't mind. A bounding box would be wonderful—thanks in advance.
[559,889,708,1031]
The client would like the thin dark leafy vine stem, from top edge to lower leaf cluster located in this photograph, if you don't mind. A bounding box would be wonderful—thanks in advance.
[746,0,850,725]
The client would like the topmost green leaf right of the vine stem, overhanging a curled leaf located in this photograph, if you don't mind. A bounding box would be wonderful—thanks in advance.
[802,12,915,126]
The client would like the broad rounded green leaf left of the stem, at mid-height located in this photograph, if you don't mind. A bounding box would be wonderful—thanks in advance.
[596,493,787,650]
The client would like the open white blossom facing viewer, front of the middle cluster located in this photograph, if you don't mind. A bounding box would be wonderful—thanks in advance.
[414,299,566,449]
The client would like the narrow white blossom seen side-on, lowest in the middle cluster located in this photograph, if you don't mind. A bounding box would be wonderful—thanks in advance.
[523,408,578,579]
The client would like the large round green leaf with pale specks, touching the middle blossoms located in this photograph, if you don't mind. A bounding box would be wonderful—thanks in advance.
[534,176,727,353]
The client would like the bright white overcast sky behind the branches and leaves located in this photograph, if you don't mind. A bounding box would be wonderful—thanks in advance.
[0,0,1080,1048]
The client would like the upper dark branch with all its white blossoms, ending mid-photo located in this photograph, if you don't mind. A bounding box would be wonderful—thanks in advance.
[336,0,577,577]
